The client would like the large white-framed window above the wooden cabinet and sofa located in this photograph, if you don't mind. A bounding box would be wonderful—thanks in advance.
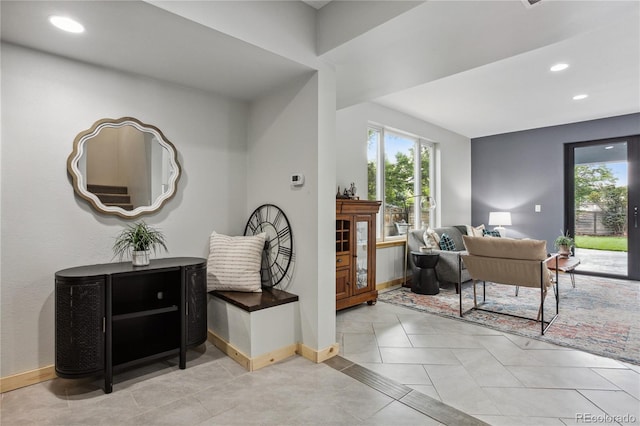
[367,126,435,239]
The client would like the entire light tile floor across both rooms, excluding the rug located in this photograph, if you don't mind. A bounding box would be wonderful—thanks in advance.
[0,280,640,426]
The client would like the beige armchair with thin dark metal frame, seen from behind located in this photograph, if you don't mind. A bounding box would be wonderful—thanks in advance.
[460,235,560,334]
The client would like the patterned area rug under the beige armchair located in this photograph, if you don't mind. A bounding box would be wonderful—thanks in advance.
[378,275,640,365]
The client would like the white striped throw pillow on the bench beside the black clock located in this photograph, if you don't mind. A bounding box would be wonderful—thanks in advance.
[207,231,266,293]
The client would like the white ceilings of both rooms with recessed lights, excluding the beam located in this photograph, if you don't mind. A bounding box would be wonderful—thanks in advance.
[0,0,640,138]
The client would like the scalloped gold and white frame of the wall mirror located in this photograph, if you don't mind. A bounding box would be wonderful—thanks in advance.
[67,117,182,219]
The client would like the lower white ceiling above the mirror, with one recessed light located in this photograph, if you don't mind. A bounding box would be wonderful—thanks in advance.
[0,0,313,101]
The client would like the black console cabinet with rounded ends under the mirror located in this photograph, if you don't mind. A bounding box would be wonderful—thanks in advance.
[55,257,207,393]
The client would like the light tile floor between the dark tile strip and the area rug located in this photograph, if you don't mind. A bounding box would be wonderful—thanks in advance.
[336,282,640,425]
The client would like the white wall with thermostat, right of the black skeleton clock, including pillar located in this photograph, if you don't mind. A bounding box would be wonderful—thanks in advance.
[246,72,335,350]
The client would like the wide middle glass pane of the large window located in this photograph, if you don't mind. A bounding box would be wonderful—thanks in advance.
[384,132,418,237]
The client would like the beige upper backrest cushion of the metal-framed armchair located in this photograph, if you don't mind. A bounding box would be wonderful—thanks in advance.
[463,235,547,260]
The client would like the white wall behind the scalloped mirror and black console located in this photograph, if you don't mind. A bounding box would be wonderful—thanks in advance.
[0,43,248,377]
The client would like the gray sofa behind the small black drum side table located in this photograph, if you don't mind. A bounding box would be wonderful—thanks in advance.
[408,225,471,293]
